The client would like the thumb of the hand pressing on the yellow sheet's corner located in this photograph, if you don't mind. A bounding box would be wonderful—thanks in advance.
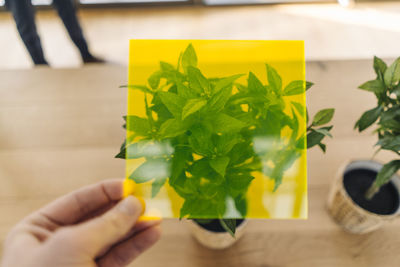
[56,196,142,257]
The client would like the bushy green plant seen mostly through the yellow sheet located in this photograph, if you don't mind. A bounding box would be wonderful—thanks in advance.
[116,44,334,235]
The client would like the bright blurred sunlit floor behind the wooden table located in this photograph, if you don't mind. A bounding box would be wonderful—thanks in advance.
[0,2,400,68]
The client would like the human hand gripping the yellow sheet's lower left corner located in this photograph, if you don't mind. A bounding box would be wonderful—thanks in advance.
[2,180,160,267]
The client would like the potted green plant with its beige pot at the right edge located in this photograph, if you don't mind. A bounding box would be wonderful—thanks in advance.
[328,57,400,234]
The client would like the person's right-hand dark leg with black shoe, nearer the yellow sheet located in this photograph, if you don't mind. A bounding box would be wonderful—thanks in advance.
[53,0,102,62]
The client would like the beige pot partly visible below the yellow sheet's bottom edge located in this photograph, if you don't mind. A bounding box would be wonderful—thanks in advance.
[187,220,247,249]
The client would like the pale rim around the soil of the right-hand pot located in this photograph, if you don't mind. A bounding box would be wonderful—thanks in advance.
[338,159,400,219]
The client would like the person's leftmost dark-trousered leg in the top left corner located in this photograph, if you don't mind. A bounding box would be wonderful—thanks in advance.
[6,0,48,65]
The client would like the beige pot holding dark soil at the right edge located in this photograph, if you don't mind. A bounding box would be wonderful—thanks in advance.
[327,160,400,234]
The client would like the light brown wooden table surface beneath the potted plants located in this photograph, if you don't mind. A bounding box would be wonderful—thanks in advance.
[0,60,400,267]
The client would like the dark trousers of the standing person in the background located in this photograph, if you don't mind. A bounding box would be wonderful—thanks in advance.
[6,0,91,64]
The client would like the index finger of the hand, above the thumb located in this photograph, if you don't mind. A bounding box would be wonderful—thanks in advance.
[38,179,123,225]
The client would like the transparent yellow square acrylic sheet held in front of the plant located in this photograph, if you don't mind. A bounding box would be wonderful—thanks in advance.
[124,40,307,219]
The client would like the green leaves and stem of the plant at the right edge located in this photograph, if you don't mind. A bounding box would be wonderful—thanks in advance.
[354,57,400,199]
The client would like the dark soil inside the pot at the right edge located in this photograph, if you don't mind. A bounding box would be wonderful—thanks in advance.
[343,169,400,215]
